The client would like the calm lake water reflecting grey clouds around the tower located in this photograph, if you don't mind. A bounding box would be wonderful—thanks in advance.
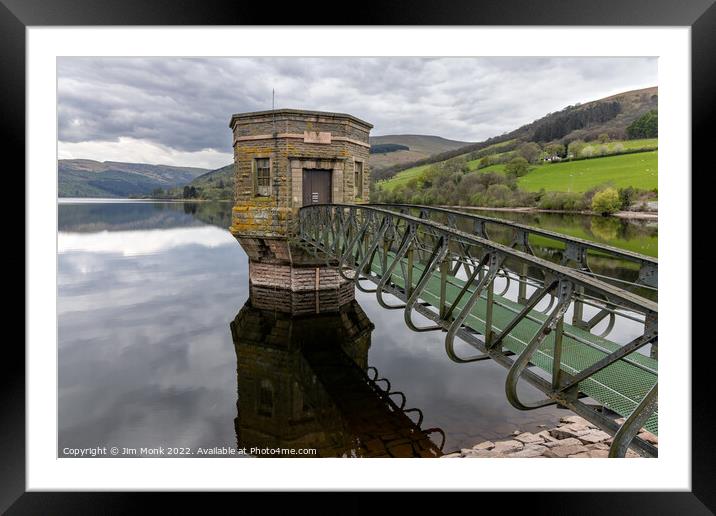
[58,202,657,456]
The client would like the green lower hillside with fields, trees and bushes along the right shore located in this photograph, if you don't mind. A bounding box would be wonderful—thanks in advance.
[378,150,658,213]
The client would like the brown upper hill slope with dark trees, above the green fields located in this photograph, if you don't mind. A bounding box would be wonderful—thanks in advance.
[371,86,659,181]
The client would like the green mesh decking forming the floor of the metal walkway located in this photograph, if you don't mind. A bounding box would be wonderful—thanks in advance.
[371,254,658,435]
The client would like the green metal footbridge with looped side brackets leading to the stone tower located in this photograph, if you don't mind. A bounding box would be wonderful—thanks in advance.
[298,205,658,457]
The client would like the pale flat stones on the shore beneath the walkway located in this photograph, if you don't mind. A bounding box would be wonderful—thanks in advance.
[442,416,658,459]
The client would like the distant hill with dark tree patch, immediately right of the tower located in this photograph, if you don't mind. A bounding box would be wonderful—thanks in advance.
[369,134,476,171]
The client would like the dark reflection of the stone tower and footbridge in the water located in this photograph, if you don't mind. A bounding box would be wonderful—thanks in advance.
[231,285,444,457]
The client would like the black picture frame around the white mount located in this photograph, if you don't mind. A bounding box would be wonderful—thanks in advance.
[7,0,716,514]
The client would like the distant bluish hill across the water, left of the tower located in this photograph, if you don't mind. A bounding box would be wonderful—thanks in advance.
[58,159,208,197]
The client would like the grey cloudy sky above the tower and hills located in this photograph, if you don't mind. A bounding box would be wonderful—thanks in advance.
[58,57,657,168]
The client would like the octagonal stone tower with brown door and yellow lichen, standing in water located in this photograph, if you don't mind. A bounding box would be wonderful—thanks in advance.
[229,109,373,291]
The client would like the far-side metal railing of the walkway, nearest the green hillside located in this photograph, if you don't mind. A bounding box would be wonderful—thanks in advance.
[367,203,659,288]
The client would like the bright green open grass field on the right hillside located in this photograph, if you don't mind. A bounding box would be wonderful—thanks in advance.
[516,151,659,192]
